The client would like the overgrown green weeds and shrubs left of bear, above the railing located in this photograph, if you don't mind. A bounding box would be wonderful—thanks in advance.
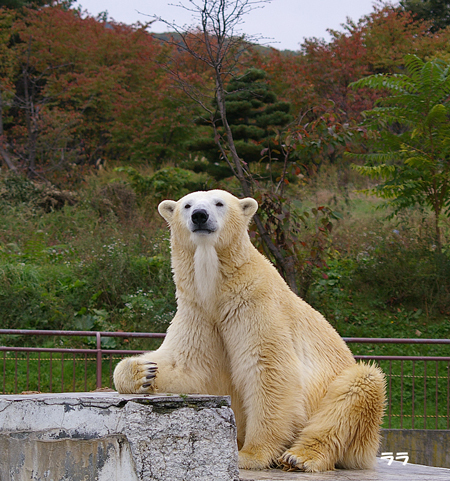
[0,173,175,342]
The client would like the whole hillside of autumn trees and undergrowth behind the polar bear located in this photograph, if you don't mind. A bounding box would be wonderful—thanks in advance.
[0,1,450,337]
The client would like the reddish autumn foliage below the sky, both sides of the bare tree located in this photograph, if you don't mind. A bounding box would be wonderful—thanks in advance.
[0,3,450,183]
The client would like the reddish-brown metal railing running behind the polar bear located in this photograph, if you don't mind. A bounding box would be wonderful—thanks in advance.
[0,329,450,429]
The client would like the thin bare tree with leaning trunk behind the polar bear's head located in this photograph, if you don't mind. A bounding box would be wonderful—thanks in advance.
[160,0,322,292]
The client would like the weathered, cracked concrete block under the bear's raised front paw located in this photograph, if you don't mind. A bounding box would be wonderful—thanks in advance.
[0,392,239,481]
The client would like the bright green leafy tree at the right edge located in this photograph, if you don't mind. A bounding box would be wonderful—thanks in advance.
[352,55,450,248]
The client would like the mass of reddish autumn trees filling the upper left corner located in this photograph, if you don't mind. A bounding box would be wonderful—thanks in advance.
[0,4,193,182]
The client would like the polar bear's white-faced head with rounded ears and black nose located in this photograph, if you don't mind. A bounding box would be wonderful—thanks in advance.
[158,190,258,245]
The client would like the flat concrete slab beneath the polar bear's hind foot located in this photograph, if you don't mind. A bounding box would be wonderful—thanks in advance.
[239,459,450,481]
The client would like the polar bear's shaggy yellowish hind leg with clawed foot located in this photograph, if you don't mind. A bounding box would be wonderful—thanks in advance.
[279,363,385,472]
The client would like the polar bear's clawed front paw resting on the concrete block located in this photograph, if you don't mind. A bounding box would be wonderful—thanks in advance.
[114,357,158,394]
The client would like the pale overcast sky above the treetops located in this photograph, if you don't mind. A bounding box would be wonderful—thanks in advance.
[75,0,398,50]
